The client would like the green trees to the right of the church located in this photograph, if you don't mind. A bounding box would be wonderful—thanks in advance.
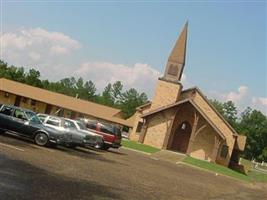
[210,100,267,161]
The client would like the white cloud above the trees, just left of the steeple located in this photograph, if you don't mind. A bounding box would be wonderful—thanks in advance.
[75,62,160,97]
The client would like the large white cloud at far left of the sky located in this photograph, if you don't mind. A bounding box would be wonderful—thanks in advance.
[0,28,81,66]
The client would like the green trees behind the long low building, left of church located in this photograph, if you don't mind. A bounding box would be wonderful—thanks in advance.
[0,60,148,118]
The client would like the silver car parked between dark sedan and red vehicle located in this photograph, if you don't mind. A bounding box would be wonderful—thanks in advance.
[37,114,103,148]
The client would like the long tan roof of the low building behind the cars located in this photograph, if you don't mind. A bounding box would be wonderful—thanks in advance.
[0,78,132,127]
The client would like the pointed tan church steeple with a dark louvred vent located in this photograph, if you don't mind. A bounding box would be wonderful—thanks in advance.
[162,22,188,82]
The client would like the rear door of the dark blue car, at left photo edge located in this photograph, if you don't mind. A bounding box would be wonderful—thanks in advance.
[0,105,14,130]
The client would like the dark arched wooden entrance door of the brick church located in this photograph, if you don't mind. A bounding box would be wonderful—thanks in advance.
[171,121,192,153]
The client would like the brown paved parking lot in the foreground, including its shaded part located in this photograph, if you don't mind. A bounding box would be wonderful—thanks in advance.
[0,135,267,200]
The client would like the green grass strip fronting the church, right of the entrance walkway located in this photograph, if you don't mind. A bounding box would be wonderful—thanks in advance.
[183,157,252,182]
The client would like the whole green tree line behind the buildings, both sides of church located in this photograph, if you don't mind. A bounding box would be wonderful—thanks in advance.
[0,60,267,161]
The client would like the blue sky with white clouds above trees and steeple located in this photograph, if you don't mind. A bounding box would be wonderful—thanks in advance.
[0,0,267,114]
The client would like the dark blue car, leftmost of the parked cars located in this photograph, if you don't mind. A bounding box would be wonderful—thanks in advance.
[0,105,64,146]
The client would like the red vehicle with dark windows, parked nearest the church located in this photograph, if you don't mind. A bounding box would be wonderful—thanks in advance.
[79,119,122,150]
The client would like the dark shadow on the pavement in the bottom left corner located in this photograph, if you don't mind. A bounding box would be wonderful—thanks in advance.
[0,155,121,200]
